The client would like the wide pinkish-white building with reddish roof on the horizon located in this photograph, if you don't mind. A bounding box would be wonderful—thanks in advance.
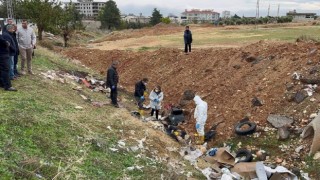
[181,9,220,23]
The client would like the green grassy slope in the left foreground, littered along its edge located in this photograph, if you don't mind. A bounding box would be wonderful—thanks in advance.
[0,48,201,179]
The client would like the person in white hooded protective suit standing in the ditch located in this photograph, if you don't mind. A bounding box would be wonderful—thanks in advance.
[193,96,208,144]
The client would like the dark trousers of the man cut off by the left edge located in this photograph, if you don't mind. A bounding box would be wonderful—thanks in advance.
[0,56,11,89]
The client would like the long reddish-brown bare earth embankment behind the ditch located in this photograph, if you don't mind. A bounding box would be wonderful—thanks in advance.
[63,41,320,140]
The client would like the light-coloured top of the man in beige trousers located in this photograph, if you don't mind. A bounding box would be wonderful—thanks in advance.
[17,27,37,49]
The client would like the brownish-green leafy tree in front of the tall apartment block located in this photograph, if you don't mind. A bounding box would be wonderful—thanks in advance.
[58,2,84,47]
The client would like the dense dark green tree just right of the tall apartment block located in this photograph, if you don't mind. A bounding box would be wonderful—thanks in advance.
[98,0,121,29]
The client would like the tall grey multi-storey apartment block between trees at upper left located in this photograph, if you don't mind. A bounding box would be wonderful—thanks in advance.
[73,0,105,19]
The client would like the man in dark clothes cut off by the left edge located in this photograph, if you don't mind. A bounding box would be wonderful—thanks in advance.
[0,28,17,91]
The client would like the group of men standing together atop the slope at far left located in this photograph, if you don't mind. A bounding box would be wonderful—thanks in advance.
[0,19,36,91]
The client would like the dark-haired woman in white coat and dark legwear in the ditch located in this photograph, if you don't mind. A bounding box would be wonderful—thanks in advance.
[149,86,163,119]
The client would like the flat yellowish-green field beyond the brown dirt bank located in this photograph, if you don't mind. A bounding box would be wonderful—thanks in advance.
[93,23,320,51]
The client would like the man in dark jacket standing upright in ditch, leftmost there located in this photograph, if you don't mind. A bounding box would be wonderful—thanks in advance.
[106,61,119,108]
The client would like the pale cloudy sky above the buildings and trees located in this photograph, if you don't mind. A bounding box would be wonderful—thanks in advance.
[109,0,320,16]
